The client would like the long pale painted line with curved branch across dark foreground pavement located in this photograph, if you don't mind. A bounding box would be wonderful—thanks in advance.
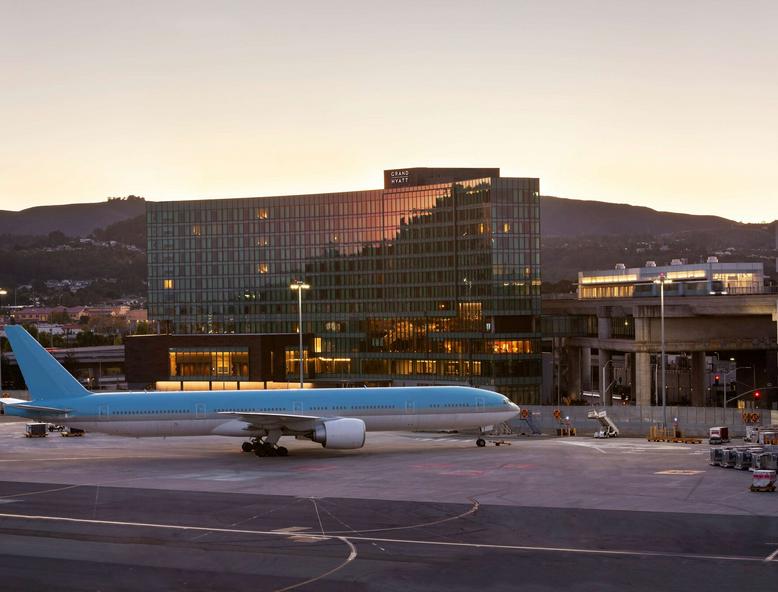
[0,513,764,564]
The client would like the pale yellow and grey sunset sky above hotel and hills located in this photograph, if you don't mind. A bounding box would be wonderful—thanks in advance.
[0,0,778,222]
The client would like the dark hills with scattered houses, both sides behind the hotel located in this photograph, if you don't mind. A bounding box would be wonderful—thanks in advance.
[0,196,776,298]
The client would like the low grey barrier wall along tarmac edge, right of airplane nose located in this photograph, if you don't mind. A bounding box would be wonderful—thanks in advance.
[509,405,778,438]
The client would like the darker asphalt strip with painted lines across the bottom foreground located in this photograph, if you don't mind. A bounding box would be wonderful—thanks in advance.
[0,482,778,591]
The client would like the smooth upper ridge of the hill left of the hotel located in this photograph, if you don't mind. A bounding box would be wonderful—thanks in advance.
[0,195,146,237]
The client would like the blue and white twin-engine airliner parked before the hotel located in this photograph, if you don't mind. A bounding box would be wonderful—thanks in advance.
[0,325,519,456]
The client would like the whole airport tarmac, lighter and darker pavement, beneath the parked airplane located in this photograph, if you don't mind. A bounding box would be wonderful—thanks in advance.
[0,418,778,591]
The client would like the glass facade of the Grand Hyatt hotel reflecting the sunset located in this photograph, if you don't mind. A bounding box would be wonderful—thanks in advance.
[147,171,541,403]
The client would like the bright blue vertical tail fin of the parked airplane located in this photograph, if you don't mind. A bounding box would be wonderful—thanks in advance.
[5,325,89,401]
